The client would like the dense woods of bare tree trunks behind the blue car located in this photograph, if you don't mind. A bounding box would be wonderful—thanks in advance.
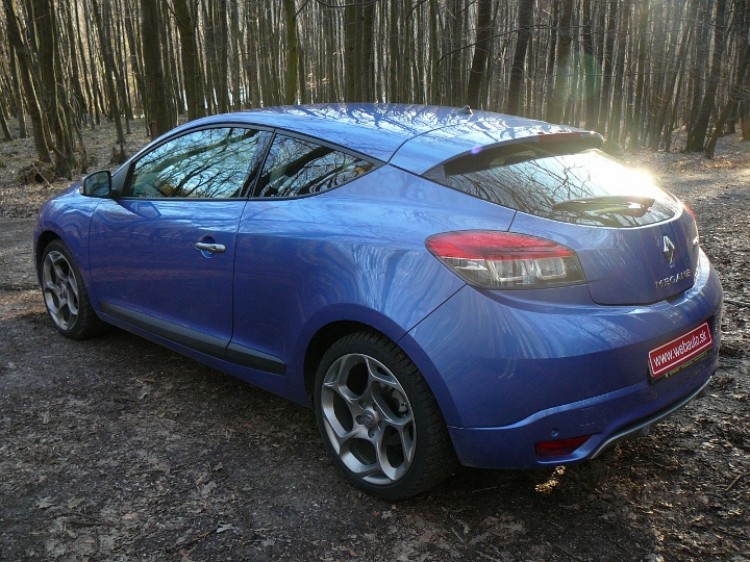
[0,0,750,177]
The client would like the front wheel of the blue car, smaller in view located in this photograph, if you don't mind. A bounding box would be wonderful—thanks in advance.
[40,240,105,340]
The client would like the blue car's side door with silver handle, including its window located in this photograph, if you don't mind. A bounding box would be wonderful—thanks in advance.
[90,126,271,355]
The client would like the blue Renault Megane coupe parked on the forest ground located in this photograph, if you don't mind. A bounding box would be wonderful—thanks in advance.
[34,104,722,499]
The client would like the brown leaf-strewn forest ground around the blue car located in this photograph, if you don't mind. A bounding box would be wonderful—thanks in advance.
[0,120,750,562]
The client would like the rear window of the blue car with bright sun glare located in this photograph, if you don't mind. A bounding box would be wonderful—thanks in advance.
[425,145,680,228]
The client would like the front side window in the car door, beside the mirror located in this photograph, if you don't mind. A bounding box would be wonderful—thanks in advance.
[127,127,271,199]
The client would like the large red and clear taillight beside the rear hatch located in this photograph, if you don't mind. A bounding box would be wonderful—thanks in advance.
[426,230,585,289]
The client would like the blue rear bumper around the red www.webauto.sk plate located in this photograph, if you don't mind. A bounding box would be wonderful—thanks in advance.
[402,249,722,468]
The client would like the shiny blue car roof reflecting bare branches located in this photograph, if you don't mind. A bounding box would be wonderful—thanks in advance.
[179,103,579,174]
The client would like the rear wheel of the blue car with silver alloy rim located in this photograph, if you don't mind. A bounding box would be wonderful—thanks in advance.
[314,331,456,500]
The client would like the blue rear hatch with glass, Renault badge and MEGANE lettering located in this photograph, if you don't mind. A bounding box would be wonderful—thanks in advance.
[425,133,699,305]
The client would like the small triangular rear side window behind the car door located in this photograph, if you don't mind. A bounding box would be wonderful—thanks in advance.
[255,134,374,197]
